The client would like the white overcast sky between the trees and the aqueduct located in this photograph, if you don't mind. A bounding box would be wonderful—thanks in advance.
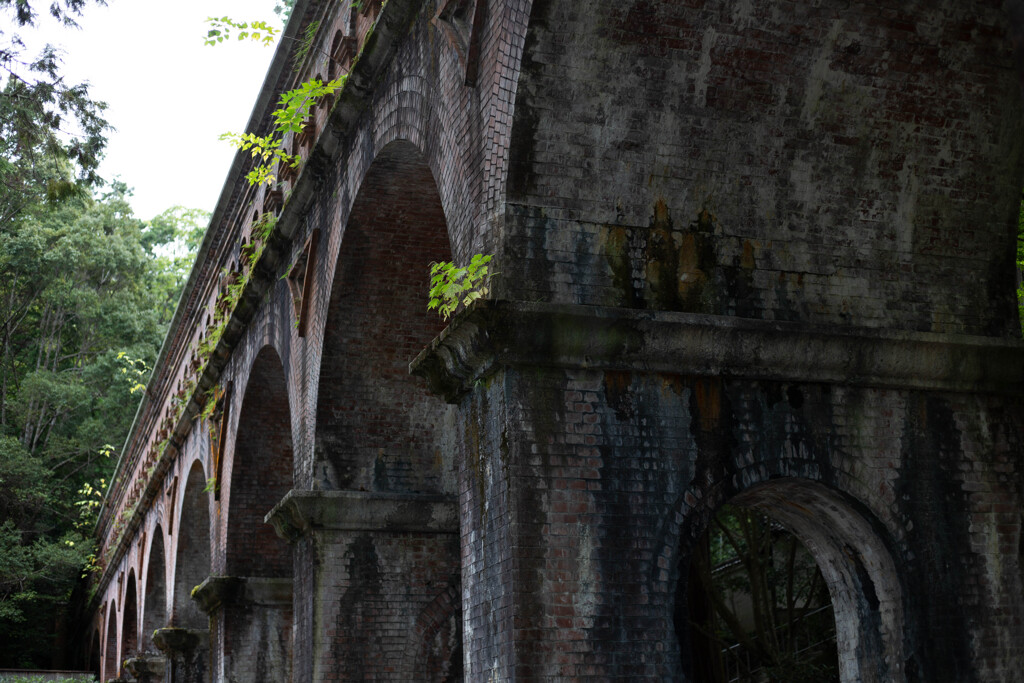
[20,0,280,220]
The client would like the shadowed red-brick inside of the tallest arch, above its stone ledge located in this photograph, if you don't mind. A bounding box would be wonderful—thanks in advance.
[314,141,454,493]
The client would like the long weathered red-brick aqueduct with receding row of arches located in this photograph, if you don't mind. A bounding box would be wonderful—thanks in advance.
[78,0,1024,683]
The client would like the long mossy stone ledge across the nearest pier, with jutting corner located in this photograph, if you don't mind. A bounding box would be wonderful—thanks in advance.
[410,300,1024,402]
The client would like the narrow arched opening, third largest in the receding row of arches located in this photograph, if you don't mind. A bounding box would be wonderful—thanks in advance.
[171,461,210,629]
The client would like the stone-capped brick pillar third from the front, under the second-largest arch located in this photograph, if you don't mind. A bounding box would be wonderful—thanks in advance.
[193,577,292,683]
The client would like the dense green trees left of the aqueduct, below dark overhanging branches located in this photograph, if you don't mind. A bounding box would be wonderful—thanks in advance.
[0,183,205,667]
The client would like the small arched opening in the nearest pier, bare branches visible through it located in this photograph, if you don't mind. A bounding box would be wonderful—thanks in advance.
[688,505,839,683]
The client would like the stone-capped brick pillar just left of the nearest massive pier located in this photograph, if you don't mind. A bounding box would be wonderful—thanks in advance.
[267,490,462,683]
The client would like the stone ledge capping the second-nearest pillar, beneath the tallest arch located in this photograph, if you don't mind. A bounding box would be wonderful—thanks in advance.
[265,489,459,542]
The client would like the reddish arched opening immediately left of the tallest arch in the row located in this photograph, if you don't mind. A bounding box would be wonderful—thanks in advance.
[226,346,292,579]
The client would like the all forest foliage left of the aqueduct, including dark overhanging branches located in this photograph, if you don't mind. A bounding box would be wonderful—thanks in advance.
[0,0,208,668]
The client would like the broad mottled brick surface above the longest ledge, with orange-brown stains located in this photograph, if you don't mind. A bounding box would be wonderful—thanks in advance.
[503,0,1021,336]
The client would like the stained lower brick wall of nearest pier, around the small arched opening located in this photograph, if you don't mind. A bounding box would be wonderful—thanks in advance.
[461,362,1022,681]
